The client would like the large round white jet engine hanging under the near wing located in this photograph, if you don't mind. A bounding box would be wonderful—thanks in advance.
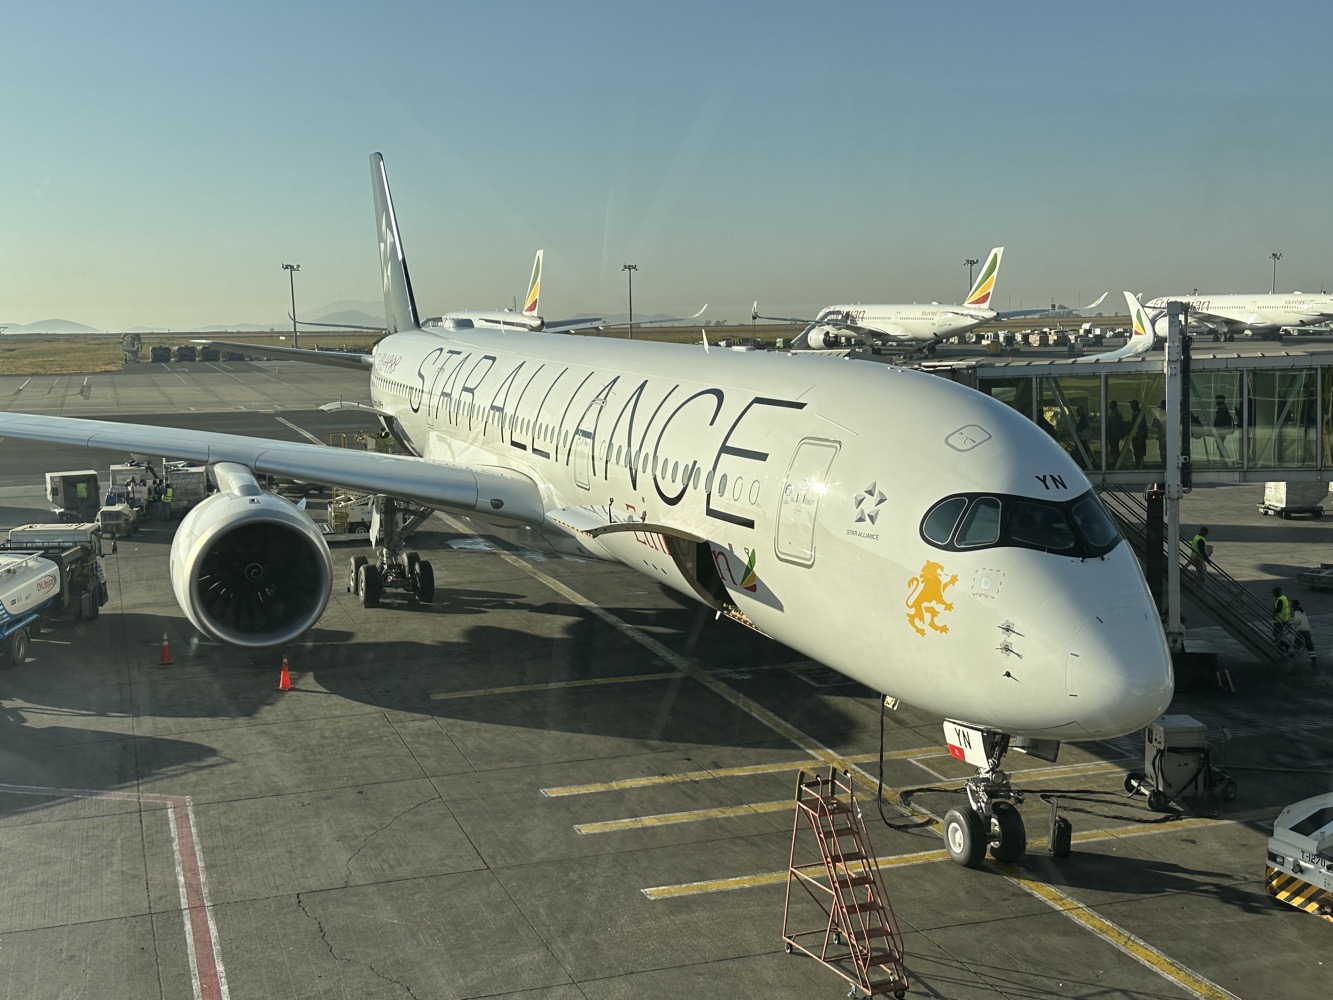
[171,463,333,649]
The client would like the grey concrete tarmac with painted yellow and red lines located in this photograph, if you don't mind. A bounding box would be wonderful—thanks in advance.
[0,361,1333,1000]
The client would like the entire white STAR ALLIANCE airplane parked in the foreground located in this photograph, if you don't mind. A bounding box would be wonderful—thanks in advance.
[0,153,1173,865]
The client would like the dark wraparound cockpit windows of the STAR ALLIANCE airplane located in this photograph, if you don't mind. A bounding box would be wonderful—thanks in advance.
[921,491,1121,559]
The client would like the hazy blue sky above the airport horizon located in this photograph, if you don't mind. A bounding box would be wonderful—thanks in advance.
[0,0,1333,329]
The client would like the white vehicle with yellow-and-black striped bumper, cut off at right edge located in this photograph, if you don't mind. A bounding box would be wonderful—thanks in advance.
[1265,792,1333,921]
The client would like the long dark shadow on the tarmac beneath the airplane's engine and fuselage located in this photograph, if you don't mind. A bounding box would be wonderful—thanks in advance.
[0,588,864,757]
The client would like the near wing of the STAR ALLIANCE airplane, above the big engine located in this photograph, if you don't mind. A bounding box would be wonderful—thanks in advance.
[0,413,545,524]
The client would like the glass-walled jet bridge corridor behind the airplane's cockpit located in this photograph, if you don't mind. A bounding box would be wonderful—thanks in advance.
[921,351,1333,488]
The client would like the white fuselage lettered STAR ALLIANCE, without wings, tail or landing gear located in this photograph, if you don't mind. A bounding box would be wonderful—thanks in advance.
[372,331,1172,739]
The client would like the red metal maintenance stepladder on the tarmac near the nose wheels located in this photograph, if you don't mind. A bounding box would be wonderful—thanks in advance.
[782,768,908,999]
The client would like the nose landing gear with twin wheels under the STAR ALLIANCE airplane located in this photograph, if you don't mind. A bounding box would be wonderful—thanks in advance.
[944,723,1028,868]
